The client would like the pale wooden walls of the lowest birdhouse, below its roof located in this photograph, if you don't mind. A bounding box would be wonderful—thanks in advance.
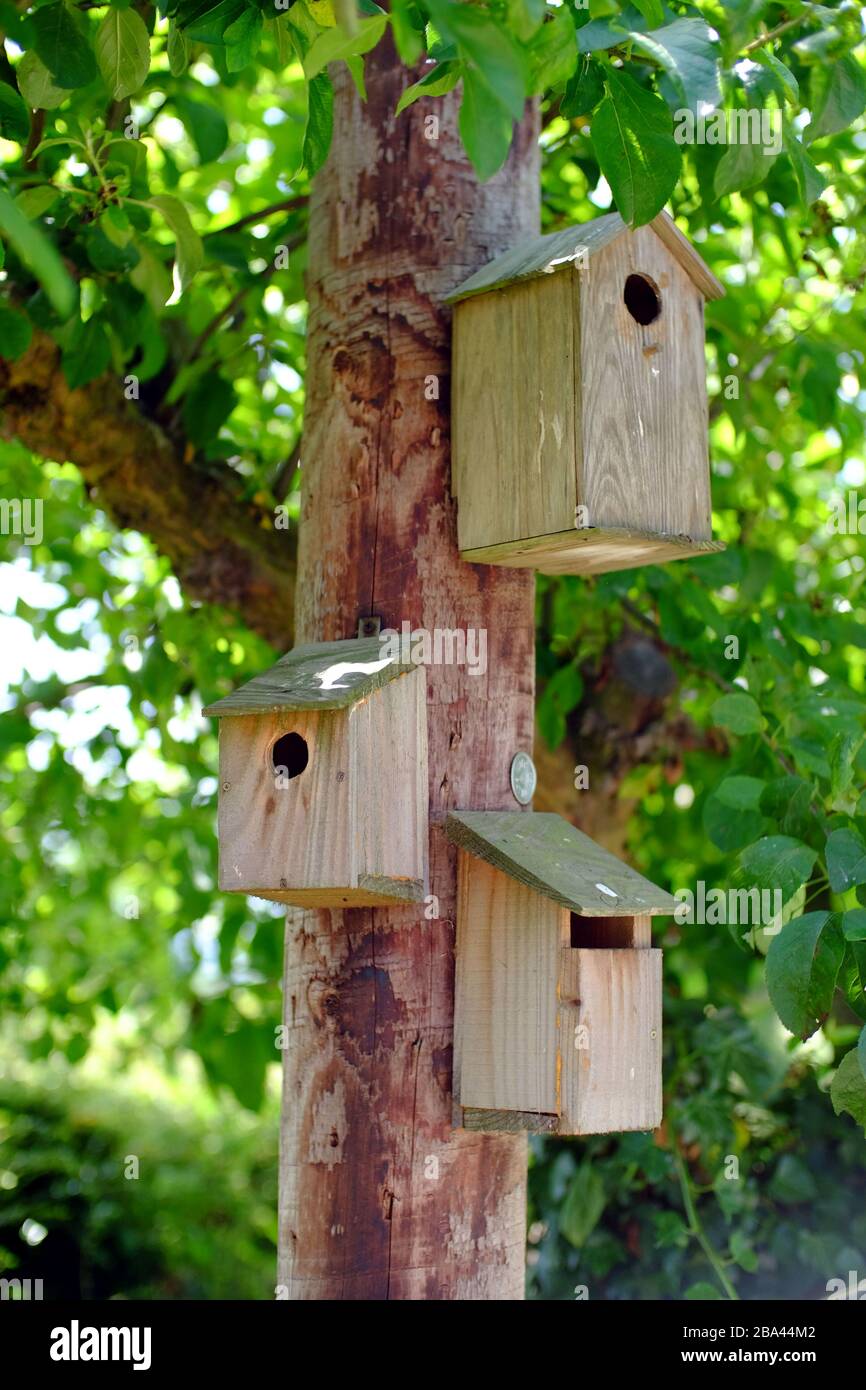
[449,839,662,1136]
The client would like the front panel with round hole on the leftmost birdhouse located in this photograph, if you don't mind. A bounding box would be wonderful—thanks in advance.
[220,710,353,902]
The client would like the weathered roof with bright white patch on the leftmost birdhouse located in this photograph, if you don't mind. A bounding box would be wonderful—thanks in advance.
[202,637,416,717]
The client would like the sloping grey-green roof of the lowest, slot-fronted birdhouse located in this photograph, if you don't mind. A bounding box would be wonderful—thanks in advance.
[445,810,677,917]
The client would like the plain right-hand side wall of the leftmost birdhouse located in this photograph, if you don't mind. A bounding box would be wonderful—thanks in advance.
[349,667,428,901]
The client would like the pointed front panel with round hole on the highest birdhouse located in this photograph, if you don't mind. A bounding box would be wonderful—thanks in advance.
[577,227,710,541]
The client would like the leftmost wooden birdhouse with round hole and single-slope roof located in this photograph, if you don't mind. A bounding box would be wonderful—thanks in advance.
[204,637,427,908]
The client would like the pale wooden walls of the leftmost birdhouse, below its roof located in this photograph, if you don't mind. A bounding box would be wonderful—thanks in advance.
[220,669,427,908]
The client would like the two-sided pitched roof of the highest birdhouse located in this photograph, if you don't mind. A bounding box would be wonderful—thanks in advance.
[446,213,724,304]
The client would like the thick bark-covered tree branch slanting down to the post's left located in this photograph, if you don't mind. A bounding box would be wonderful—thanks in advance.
[0,334,296,651]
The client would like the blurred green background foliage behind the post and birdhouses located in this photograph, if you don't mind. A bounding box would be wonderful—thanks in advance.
[0,0,866,1300]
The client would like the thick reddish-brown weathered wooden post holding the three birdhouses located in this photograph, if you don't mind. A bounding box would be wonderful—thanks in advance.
[278,46,539,1300]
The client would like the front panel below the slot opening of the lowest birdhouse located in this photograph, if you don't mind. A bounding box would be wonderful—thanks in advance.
[559,948,662,1134]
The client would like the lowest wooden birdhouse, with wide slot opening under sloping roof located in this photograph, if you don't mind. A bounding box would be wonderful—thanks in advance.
[445,812,676,1134]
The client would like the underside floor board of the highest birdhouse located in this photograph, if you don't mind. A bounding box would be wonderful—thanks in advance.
[460,527,724,574]
